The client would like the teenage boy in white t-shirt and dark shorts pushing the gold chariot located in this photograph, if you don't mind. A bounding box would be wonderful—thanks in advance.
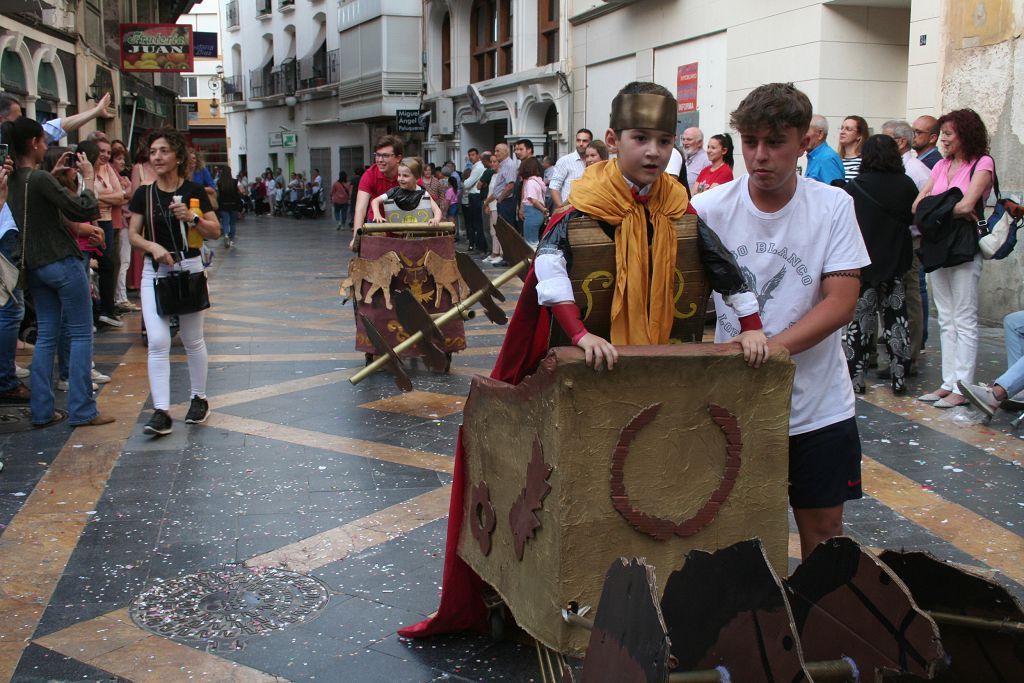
[693,83,870,558]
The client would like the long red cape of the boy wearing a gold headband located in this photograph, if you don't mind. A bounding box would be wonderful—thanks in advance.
[398,210,571,638]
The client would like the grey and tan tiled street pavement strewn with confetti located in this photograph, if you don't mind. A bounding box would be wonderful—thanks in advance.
[0,219,1024,681]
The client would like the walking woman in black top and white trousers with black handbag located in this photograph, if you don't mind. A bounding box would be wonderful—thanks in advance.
[129,129,220,436]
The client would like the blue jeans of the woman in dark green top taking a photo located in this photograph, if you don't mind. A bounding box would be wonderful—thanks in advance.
[29,256,97,425]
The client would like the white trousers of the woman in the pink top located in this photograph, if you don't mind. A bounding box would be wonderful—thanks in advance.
[928,254,981,393]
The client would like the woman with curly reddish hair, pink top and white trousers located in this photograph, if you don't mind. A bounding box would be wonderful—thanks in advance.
[913,110,995,408]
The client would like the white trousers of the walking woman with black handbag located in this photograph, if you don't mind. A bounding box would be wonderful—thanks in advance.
[139,255,209,411]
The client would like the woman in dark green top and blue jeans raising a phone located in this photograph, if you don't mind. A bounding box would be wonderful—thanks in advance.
[2,117,114,427]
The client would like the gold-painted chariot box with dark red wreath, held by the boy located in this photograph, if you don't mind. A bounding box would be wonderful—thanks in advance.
[459,344,794,655]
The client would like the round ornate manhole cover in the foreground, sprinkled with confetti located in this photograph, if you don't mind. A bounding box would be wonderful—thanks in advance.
[128,564,330,650]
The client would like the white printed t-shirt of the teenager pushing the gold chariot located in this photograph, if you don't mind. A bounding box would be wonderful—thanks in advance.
[692,175,870,435]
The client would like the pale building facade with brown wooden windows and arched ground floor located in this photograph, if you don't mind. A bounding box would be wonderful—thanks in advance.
[423,0,577,168]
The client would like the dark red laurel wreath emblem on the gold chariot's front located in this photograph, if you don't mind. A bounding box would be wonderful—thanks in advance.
[611,403,742,541]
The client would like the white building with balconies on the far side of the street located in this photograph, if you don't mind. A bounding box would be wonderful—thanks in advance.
[222,0,423,185]
